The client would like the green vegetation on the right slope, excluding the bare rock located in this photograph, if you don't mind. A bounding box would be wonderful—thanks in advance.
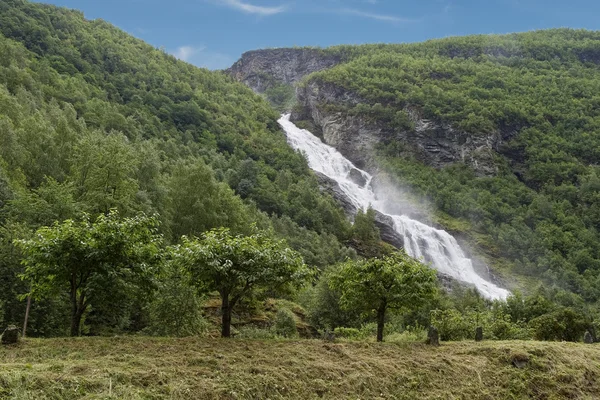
[303,29,600,303]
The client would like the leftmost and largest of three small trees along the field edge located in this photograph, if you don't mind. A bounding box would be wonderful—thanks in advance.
[15,211,162,336]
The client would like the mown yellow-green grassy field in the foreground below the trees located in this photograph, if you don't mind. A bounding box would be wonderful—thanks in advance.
[0,337,600,400]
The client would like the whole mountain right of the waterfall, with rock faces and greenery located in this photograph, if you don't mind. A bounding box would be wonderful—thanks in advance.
[228,29,600,302]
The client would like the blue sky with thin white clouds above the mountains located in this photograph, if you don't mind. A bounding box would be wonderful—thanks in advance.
[34,0,600,69]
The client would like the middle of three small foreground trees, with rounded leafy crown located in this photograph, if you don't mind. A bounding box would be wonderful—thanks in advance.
[173,229,310,337]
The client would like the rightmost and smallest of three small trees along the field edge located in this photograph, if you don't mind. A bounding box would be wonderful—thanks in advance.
[330,252,437,341]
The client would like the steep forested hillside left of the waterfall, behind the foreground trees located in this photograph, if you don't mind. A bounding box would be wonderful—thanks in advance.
[0,0,354,336]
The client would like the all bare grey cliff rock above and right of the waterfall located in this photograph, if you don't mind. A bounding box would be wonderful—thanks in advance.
[226,48,516,176]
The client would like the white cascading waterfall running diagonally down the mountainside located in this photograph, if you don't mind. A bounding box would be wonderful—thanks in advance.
[279,115,510,300]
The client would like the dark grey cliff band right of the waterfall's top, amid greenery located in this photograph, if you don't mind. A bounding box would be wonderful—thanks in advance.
[291,81,516,176]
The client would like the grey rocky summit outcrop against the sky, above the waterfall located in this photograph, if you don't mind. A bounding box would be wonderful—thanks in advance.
[226,48,340,93]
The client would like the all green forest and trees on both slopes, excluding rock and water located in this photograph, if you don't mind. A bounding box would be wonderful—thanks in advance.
[0,0,600,341]
